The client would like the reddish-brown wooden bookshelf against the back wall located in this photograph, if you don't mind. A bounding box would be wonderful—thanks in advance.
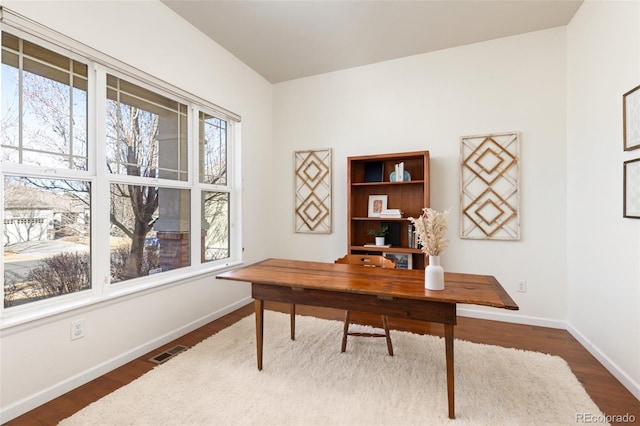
[347,151,429,269]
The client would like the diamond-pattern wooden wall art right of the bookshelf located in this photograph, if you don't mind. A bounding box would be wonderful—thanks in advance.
[460,132,520,240]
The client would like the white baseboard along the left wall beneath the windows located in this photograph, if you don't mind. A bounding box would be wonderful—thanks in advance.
[0,297,253,424]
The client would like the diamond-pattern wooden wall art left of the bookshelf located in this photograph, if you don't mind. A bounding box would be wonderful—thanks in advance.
[294,149,332,234]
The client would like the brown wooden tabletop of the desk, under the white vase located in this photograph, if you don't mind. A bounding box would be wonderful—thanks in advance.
[216,259,519,310]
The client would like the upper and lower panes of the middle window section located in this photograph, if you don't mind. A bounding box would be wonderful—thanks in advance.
[107,76,190,282]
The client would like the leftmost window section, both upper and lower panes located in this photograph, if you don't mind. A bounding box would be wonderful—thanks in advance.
[1,33,91,308]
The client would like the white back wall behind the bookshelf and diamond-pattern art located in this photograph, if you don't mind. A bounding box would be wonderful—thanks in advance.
[272,27,567,327]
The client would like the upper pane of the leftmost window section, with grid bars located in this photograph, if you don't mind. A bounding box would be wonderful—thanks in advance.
[2,33,87,170]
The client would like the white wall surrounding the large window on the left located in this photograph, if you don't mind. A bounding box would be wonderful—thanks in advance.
[0,1,272,423]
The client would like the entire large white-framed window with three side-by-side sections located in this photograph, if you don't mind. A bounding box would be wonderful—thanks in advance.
[0,30,241,310]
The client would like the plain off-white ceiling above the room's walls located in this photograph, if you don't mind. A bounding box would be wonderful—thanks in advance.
[161,0,582,83]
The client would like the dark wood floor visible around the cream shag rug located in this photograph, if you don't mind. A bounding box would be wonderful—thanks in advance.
[6,303,640,426]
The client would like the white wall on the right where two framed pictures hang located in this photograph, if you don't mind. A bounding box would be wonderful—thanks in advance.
[567,1,640,398]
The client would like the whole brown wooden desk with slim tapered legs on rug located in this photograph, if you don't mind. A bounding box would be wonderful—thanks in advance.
[217,259,518,419]
